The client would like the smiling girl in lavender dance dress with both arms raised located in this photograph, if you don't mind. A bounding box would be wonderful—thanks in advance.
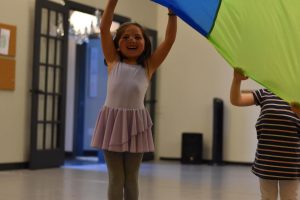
[92,0,177,200]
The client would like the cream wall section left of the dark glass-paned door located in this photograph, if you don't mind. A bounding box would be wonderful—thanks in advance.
[0,0,34,163]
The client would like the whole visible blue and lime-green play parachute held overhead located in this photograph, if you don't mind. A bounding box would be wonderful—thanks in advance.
[152,0,300,103]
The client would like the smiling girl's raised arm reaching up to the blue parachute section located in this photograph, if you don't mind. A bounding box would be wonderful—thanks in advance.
[148,10,177,75]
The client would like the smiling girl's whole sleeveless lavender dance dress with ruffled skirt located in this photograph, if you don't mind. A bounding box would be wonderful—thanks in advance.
[91,62,154,153]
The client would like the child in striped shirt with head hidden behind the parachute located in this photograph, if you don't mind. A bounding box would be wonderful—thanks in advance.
[230,70,300,200]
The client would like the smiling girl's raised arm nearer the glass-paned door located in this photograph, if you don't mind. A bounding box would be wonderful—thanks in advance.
[100,0,118,66]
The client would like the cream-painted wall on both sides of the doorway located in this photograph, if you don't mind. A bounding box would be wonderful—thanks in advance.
[0,0,258,163]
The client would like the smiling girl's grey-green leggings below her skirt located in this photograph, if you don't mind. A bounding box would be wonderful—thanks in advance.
[104,151,143,200]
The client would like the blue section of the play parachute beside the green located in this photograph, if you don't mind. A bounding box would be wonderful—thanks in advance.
[152,0,222,37]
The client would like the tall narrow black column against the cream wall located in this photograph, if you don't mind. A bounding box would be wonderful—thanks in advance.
[212,98,223,165]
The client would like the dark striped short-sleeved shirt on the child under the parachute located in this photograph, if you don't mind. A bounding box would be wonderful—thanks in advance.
[252,89,300,180]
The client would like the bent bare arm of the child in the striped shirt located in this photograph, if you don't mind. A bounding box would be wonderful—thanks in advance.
[230,69,255,106]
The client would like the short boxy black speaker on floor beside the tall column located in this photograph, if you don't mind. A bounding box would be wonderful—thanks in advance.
[181,133,203,164]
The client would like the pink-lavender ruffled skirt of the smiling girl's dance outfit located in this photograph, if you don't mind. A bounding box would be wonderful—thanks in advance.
[91,106,154,153]
